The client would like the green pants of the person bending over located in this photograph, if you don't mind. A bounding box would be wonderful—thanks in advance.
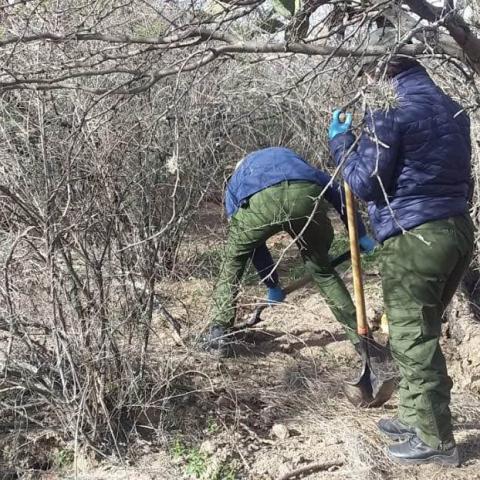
[211,181,358,343]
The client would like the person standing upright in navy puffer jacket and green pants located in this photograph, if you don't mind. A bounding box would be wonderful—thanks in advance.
[330,28,474,466]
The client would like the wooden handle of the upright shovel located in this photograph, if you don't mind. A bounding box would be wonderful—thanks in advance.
[344,182,368,335]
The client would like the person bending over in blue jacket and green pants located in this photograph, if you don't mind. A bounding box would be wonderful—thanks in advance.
[205,147,375,357]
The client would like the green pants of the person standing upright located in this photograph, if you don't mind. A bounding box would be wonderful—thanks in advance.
[382,215,473,449]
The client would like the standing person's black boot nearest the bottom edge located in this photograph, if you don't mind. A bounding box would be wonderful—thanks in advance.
[388,435,460,467]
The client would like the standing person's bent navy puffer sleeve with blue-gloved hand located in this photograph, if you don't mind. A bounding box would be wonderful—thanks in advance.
[330,110,400,202]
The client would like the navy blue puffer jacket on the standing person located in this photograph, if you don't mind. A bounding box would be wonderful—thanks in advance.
[330,66,471,242]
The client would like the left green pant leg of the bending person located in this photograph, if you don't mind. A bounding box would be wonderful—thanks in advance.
[210,188,282,328]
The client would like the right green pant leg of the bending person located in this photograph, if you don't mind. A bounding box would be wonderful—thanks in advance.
[284,184,359,344]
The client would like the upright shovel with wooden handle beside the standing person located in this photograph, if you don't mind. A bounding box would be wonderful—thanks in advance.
[344,182,396,407]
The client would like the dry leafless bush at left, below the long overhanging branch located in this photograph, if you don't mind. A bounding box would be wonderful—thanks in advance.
[0,36,350,468]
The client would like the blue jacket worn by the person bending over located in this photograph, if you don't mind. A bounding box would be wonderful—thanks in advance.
[225,147,366,288]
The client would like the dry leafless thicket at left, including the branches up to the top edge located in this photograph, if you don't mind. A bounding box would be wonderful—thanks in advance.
[0,0,480,472]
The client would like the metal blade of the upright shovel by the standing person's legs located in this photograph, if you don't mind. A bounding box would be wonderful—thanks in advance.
[343,337,396,408]
